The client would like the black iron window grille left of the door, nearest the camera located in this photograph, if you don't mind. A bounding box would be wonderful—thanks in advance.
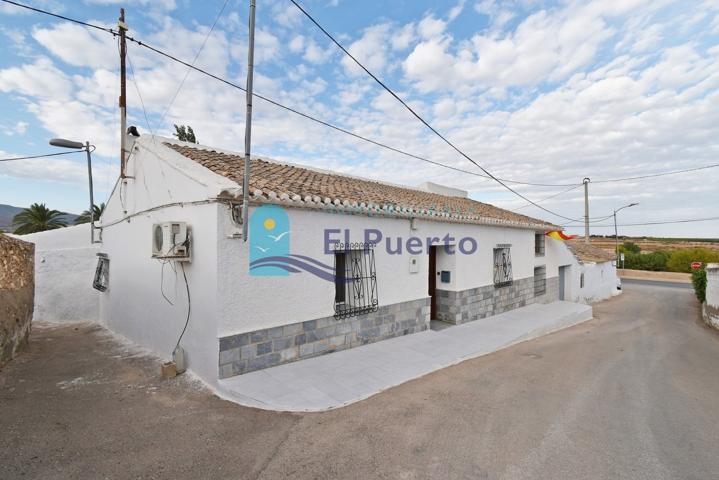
[334,243,379,318]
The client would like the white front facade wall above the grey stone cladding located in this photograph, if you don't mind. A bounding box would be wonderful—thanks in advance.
[218,208,556,336]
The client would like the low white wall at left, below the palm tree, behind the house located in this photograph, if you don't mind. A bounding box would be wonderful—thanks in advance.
[18,224,100,323]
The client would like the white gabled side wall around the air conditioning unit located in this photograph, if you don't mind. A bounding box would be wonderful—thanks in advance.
[95,137,236,381]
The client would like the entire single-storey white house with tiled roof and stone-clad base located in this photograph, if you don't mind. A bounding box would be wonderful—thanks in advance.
[90,135,615,383]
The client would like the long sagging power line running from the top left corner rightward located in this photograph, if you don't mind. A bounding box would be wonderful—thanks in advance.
[0,0,581,191]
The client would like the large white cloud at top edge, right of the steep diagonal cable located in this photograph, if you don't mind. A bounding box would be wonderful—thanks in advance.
[404,1,624,92]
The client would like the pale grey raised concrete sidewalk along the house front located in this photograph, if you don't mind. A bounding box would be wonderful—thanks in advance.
[217,302,592,412]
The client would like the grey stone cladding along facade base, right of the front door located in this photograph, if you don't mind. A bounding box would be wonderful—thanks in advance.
[437,277,559,324]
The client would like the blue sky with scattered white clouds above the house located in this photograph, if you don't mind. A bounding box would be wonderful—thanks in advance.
[0,0,719,237]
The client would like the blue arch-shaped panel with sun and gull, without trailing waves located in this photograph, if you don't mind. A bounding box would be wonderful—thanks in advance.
[250,205,290,277]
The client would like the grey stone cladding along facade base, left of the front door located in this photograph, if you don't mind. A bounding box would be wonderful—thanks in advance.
[219,298,430,378]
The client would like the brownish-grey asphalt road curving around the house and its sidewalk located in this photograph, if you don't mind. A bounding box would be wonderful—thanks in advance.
[0,284,719,480]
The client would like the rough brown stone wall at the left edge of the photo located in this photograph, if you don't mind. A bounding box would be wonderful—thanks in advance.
[0,234,35,366]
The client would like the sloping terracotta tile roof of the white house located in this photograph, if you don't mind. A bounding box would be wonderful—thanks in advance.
[165,143,556,228]
